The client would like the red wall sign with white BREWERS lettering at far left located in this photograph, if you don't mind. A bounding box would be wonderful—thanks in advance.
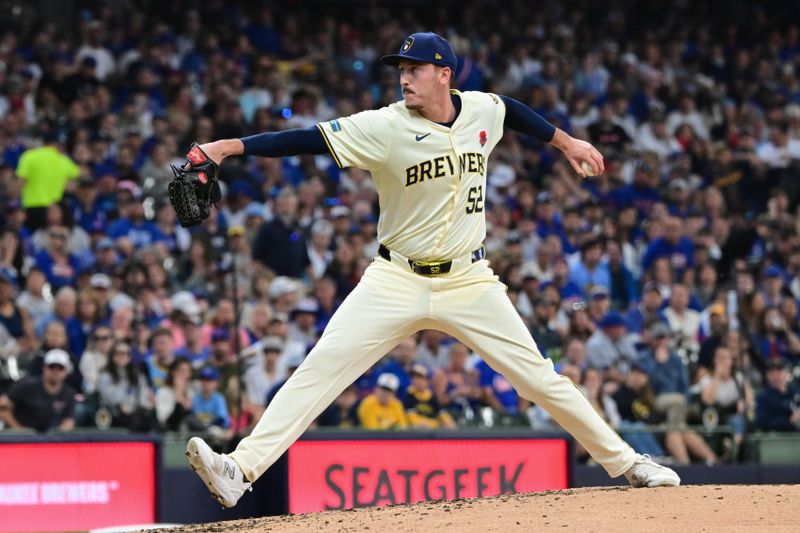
[0,442,156,532]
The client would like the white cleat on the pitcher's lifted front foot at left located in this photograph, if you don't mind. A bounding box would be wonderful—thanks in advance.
[186,437,253,507]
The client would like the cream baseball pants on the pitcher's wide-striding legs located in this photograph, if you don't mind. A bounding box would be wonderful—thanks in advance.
[231,257,635,481]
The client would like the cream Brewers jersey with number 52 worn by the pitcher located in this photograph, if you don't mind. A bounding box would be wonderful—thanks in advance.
[317,90,505,261]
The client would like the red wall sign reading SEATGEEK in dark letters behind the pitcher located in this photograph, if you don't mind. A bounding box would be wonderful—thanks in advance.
[289,438,571,513]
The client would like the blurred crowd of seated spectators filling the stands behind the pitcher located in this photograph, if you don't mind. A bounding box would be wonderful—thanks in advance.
[0,0,800,464]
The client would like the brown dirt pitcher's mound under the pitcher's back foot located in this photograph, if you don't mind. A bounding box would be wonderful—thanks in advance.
[162,485,800,533]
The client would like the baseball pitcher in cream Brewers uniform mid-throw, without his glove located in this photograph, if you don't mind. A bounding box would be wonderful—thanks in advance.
[187,33,680,507]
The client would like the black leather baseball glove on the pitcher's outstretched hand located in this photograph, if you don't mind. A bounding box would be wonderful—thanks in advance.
[168,143,222,228]
